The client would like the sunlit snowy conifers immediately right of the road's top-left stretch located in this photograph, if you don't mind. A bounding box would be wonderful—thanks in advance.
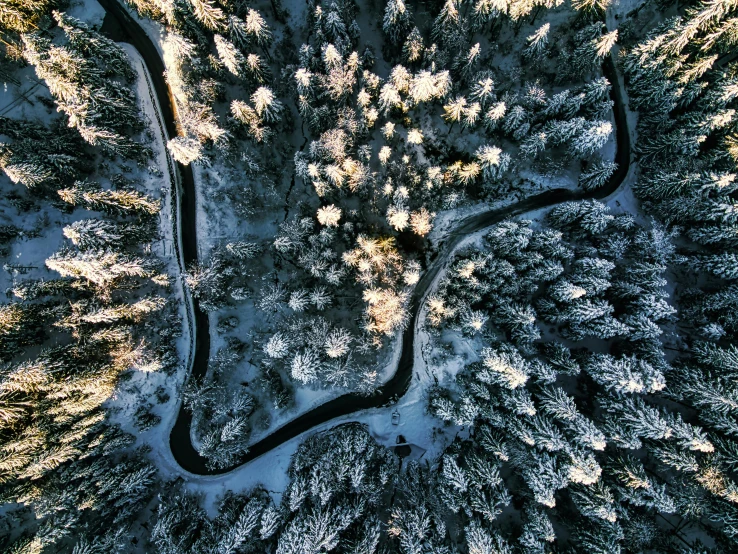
[123,0,282,165]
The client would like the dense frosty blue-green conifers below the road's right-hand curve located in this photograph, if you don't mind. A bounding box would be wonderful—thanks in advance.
[428,202,736,552]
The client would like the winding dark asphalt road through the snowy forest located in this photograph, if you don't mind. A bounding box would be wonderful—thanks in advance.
[98,0,631,475]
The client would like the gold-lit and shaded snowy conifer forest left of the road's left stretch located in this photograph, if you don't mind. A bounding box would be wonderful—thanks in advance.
[0,6,181,553]
